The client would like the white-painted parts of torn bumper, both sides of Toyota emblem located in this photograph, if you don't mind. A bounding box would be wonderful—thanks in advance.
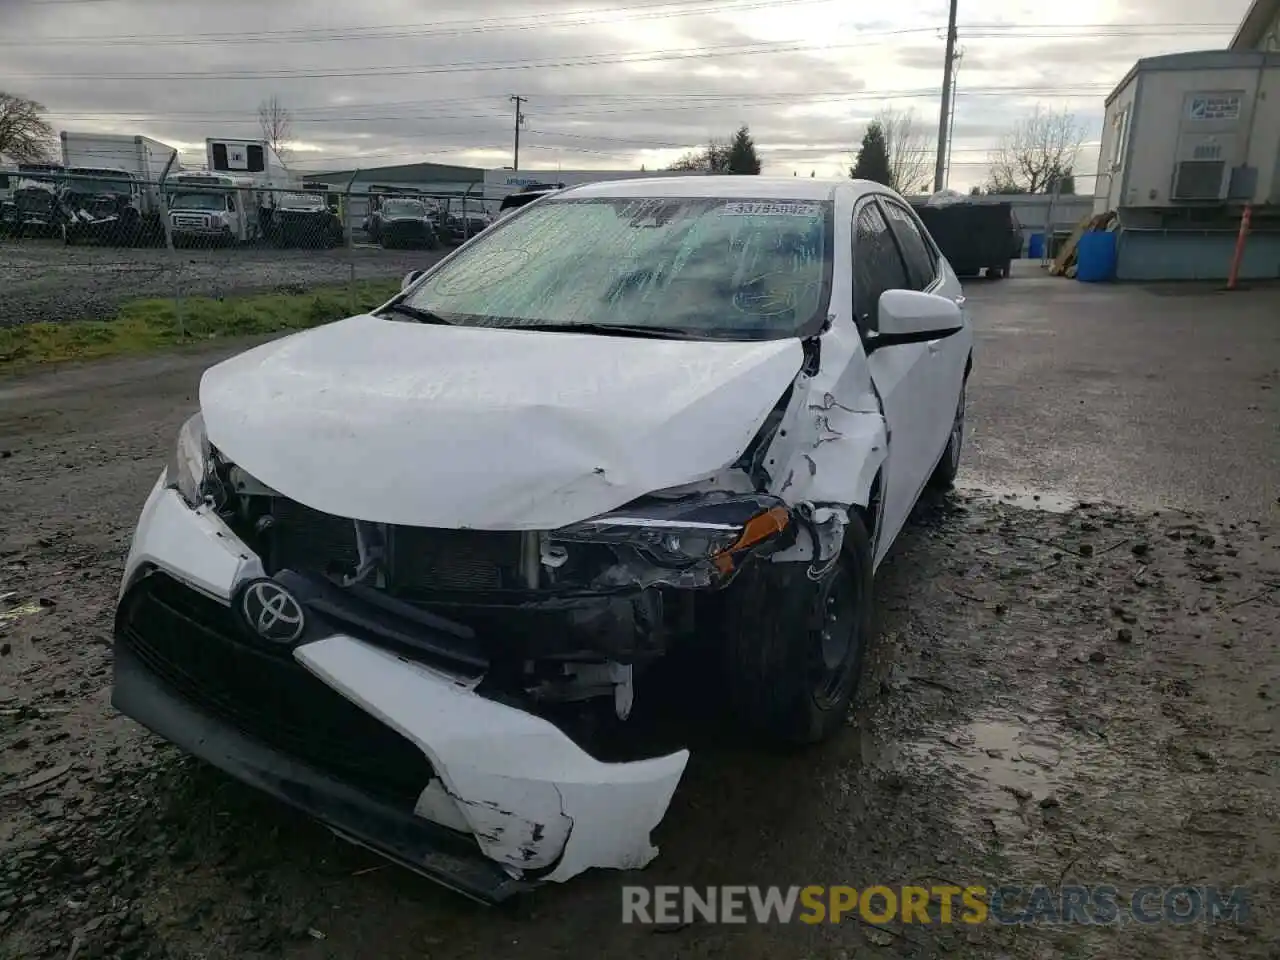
[124,491,689,881]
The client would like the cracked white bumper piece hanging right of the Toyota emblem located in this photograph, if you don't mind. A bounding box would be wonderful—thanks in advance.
[296,636,689,881]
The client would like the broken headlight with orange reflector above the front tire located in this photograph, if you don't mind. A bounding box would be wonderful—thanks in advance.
[550,497,791,573]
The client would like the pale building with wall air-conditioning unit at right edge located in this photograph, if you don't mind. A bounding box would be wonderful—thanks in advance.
[1093,0,1280,280]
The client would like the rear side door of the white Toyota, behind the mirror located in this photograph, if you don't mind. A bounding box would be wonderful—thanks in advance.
[879,197,968,479]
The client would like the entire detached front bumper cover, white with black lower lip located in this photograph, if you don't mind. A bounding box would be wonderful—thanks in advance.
[113,483,689,900]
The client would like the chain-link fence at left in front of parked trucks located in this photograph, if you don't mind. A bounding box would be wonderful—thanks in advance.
[0,170,497,339]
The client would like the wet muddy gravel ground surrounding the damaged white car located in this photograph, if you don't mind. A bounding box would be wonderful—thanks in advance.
[0,267,1280,960]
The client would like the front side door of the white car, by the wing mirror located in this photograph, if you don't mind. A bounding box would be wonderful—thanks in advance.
[854,198,937,563]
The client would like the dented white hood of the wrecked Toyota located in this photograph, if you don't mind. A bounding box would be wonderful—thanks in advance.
[200,315,803,530]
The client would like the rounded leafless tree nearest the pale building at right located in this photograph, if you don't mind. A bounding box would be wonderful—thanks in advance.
[989,104,1084,193]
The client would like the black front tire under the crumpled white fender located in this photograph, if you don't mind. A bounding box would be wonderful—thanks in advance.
[724,513,872,746]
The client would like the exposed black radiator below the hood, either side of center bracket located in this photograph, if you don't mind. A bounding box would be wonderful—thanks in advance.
[270,497,521,596]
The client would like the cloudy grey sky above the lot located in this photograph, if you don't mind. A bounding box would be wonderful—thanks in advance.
[0,0,1248,191]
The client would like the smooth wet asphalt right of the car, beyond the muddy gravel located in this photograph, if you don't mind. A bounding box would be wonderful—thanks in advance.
[964,265,1280,518]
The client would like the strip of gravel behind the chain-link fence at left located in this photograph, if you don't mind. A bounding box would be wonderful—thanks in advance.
[0,241,443,326]
